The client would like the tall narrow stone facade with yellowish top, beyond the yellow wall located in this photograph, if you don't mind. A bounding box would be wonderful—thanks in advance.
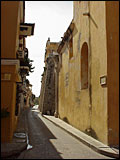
[39,39,59,115]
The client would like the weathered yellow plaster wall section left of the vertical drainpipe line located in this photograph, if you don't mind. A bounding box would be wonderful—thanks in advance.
[59,1,90,131]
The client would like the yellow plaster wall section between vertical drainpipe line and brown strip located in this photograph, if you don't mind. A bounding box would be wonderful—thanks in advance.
[90,1,108,144]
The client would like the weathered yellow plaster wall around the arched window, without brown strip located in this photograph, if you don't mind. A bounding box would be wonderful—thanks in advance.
[59,1,118,144]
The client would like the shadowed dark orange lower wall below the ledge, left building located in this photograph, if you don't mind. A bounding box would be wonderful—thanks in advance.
[1,66,17,142]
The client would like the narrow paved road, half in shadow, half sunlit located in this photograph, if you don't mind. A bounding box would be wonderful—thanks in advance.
[18,109,113,159]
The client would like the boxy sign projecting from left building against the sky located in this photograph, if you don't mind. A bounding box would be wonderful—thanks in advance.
[20,23,35,37]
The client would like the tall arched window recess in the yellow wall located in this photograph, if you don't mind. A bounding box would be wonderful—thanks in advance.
[81,42,88,89]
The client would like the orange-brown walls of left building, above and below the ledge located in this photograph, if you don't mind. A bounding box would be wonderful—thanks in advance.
[1,1,24,142]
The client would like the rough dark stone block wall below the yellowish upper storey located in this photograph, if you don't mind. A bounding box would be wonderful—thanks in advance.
[39,53,59,115]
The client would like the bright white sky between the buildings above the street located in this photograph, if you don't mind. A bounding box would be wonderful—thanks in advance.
[25,1,73,97]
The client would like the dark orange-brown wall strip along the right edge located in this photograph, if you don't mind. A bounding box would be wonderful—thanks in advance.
[106,1,119,145]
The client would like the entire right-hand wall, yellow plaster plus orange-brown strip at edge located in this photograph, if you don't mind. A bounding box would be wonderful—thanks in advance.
[59,1,119,145]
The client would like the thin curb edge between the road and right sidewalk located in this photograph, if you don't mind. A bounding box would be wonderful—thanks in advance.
[42,115,119,158]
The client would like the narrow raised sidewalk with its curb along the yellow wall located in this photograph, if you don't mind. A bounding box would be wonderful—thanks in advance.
[42,115,119,158]
